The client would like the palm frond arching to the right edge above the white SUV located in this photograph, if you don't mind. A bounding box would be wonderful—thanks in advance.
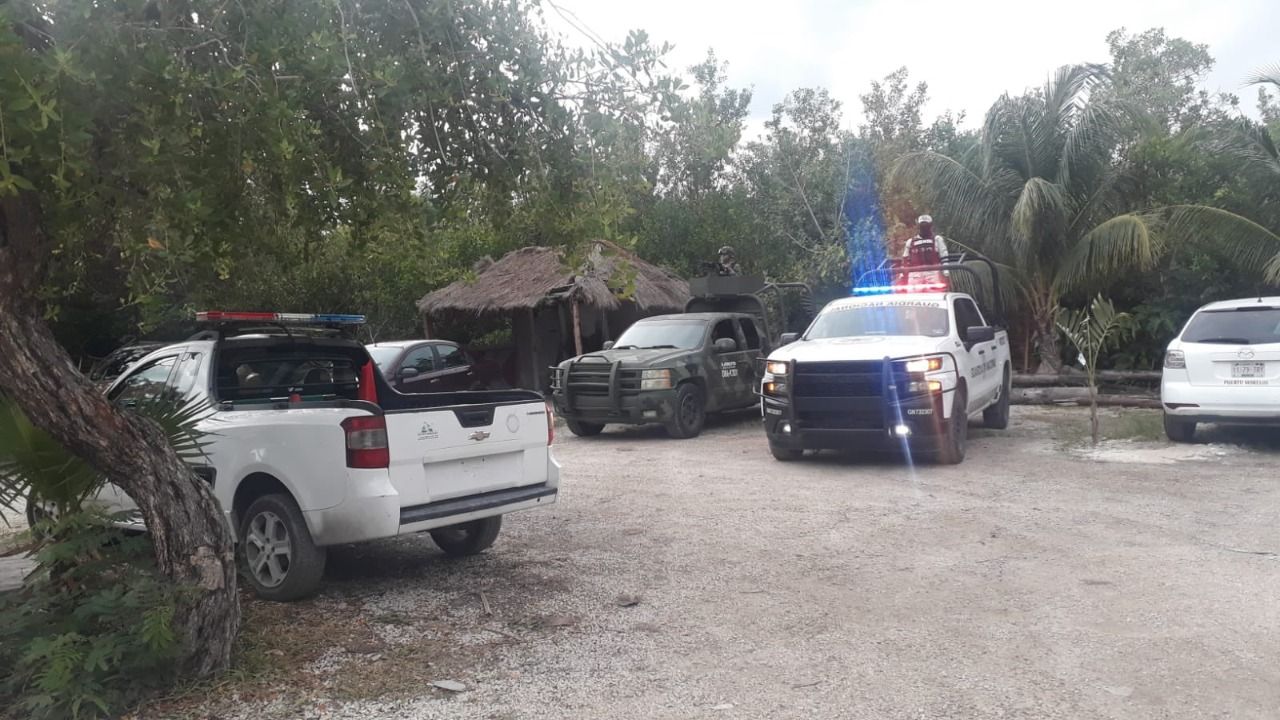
[1162,205,1280,284]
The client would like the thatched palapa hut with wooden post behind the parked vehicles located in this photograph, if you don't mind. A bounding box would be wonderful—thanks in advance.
[417,240,689,389]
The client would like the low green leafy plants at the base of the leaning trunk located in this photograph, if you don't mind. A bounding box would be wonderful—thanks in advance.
[0,512,179,720]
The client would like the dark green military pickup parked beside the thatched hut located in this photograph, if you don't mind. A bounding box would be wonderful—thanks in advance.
[552,313,771,438]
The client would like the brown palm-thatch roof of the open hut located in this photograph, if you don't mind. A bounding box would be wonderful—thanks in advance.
[417,240,689,315]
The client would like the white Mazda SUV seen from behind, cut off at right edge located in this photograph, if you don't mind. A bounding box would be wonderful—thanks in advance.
[1160,297,1280,442]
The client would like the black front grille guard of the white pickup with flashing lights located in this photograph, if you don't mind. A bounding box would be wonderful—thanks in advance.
[791,360,906,430]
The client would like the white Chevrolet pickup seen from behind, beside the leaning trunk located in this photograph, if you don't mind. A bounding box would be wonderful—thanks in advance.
[82,313,559,601]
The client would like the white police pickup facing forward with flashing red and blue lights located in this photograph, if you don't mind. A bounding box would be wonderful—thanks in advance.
[760,264,1012,464]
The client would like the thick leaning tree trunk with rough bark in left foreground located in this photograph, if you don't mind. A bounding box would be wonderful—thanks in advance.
[0,193,239,676]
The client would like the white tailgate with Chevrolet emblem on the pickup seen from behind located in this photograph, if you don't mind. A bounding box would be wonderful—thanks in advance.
[385,401,549,507]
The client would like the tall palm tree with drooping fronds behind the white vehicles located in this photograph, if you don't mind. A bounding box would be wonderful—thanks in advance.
[891,65,1280,372]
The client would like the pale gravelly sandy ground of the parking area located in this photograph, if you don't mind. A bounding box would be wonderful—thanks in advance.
[122,409,1280,720]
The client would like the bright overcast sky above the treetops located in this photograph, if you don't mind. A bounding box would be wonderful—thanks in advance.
[545,0,1280,135]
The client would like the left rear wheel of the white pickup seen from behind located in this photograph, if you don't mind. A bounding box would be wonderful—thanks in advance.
[237,495,326,602]
